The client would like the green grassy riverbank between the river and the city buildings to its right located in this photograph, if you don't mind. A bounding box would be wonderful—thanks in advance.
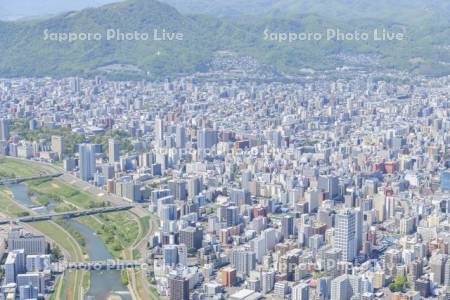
[0,158,156,299]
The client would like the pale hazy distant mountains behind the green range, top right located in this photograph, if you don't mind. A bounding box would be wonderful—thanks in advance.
[162,0,450,22]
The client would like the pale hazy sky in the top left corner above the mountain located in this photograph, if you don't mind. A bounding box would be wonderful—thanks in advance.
[0,0,120,20]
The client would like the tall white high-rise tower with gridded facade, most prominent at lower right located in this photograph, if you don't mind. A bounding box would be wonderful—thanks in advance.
[335,209,357,261]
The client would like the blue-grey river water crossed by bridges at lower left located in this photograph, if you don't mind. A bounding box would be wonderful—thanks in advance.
[7,183,132,300]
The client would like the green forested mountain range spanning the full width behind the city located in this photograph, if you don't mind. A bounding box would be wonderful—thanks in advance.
[0,0,450,78]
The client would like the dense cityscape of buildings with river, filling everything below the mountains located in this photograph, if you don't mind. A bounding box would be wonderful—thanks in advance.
[0,63,450,300]
